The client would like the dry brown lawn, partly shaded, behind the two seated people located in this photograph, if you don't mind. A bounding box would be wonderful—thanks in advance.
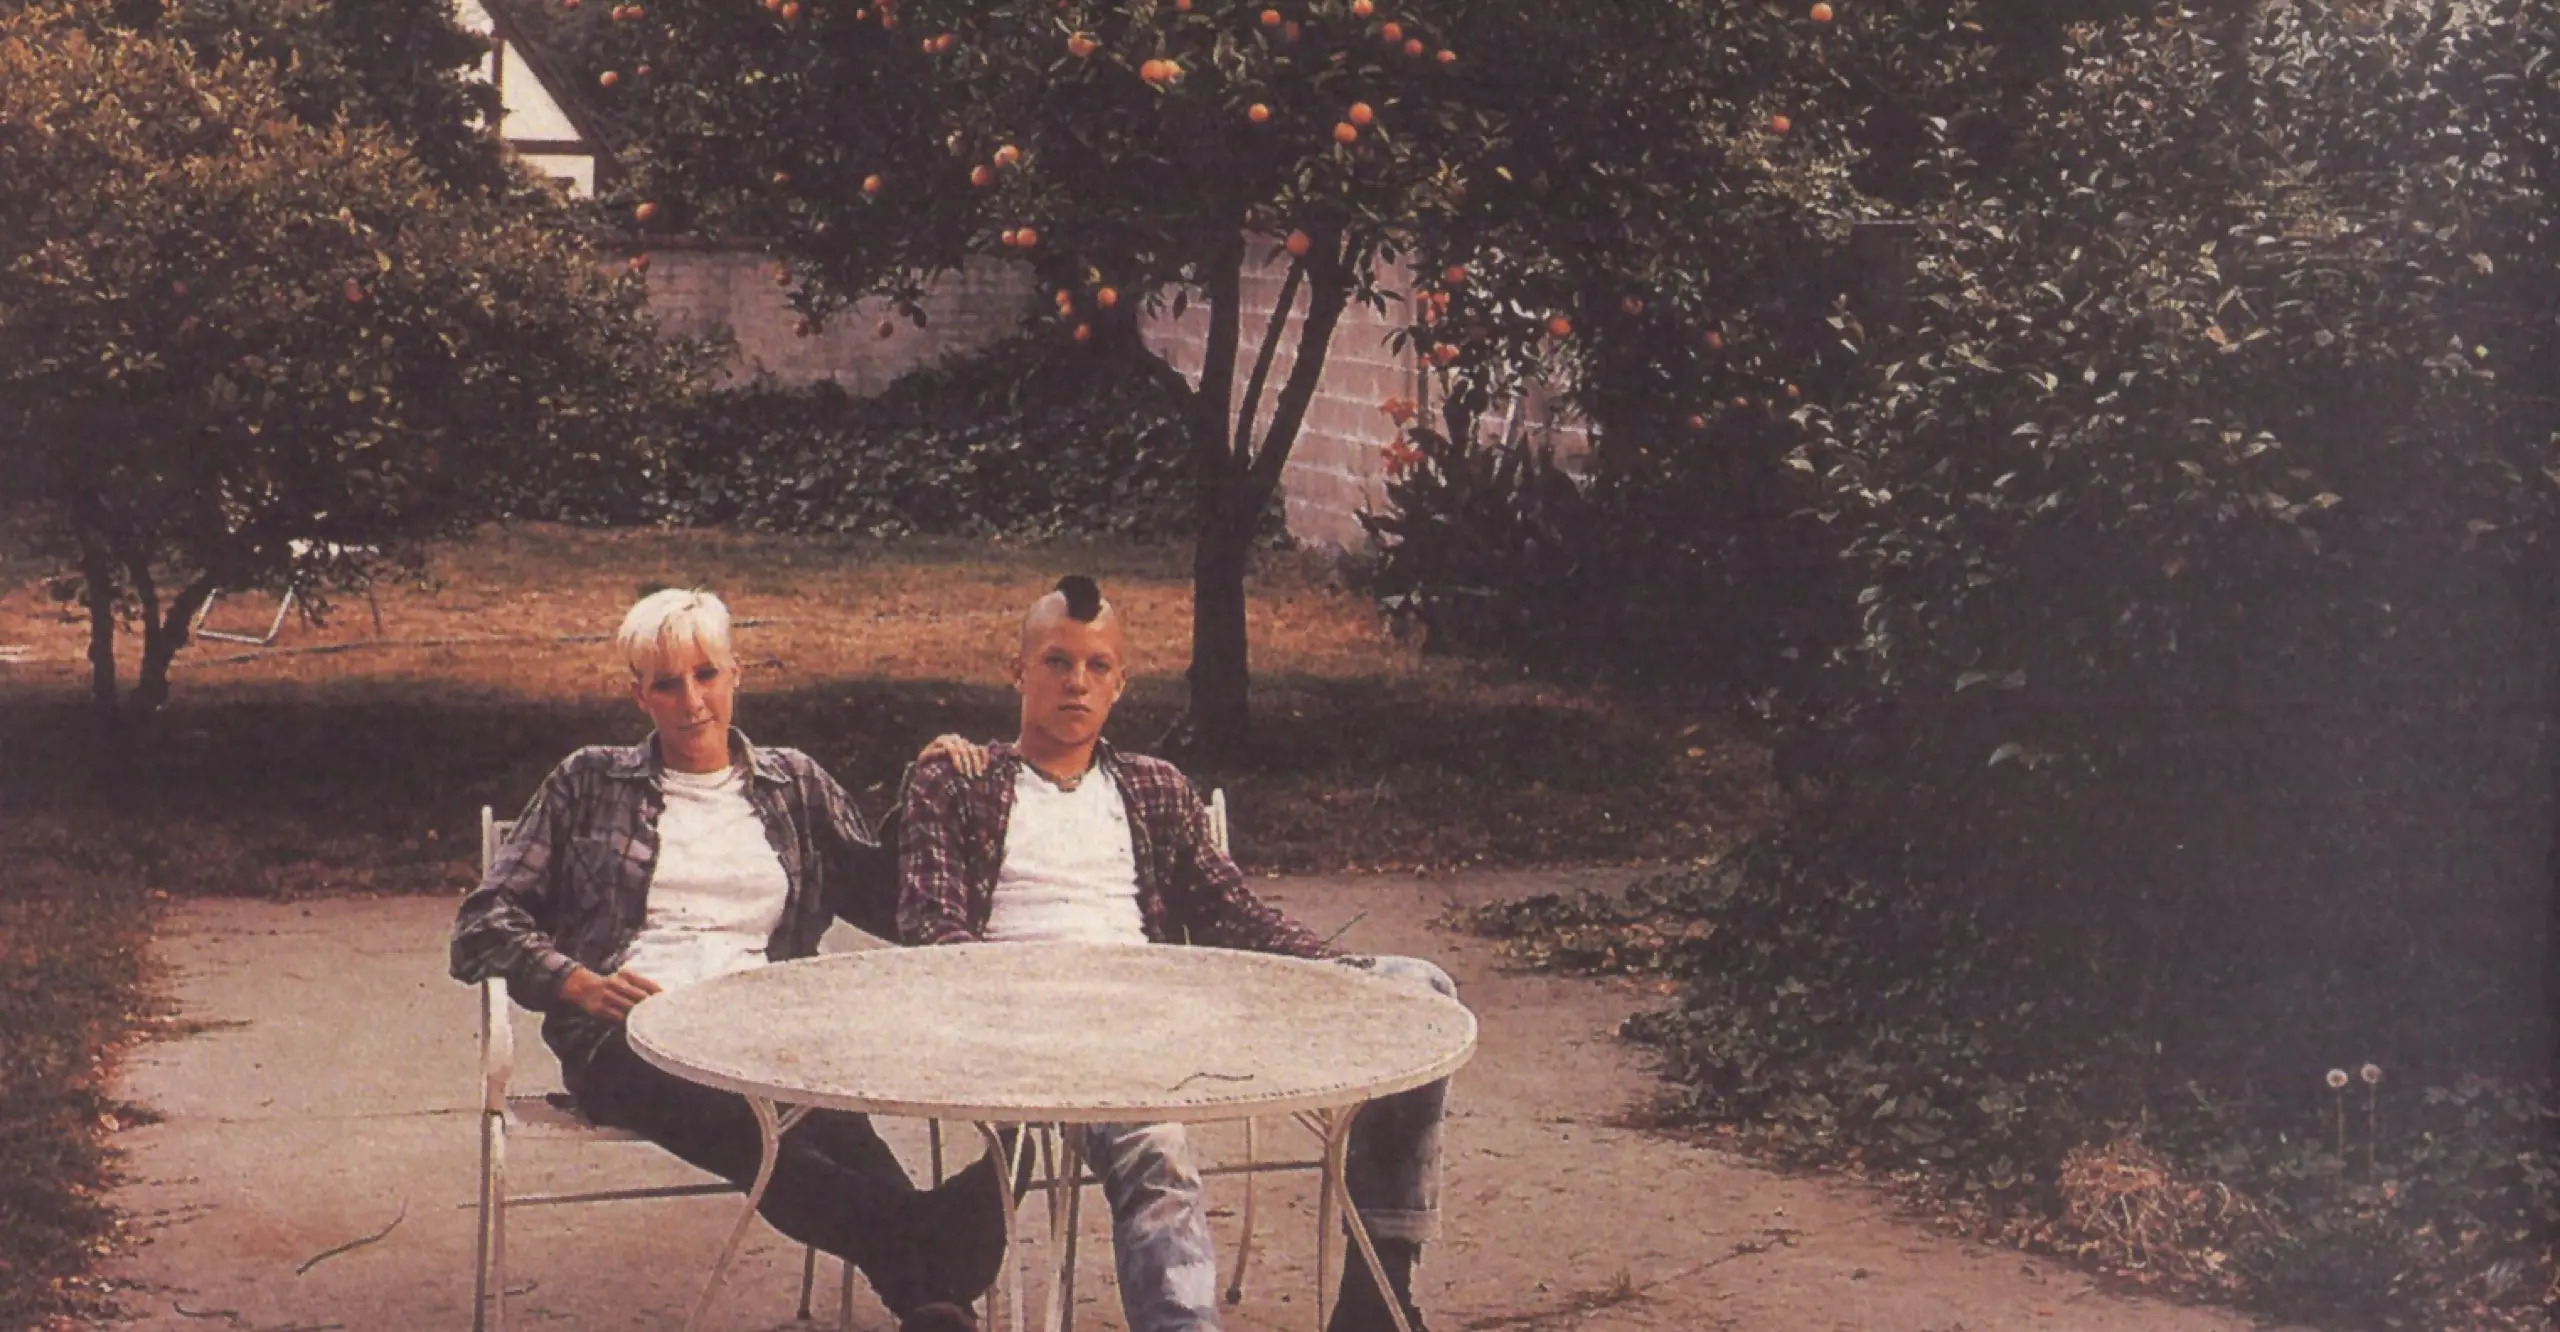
[0,525,1766,894]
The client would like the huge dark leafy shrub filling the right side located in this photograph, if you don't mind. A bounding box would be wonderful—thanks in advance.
[1433,3,2560,1327]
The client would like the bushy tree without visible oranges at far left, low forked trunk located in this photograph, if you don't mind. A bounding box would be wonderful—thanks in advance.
[0,10,691,727]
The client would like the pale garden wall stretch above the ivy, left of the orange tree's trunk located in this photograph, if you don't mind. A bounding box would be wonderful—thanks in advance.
[648,243,1032,397]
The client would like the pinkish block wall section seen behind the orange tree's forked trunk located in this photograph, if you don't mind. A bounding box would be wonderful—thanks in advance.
[1139,236,1423,548]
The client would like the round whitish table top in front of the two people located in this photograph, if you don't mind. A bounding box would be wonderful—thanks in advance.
[630,943,1475,1125]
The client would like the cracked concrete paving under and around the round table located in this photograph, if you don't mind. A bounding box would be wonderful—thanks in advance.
[108,873,2283,1332]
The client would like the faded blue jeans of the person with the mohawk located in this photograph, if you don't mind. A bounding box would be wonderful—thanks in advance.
[1078,958,1457,1332]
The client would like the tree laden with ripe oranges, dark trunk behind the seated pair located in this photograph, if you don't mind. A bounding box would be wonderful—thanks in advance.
[596,0,1838,753]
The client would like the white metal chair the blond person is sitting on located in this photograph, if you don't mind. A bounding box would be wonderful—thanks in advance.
[471,804,852,1332]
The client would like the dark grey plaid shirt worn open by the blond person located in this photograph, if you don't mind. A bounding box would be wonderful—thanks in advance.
[451,730,899,1063]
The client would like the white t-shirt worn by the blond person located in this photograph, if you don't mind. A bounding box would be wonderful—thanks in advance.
[620,768,791,989]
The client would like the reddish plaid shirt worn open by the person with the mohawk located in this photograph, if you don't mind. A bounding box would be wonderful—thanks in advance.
[899,743,1331,958]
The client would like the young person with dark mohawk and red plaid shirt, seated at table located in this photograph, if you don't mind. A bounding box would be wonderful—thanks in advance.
[899,576,1457,1332]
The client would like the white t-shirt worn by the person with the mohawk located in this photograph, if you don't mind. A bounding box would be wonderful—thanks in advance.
[986,763,1147,943]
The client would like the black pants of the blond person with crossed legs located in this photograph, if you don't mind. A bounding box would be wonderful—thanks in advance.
[563,1032,952,1317]
